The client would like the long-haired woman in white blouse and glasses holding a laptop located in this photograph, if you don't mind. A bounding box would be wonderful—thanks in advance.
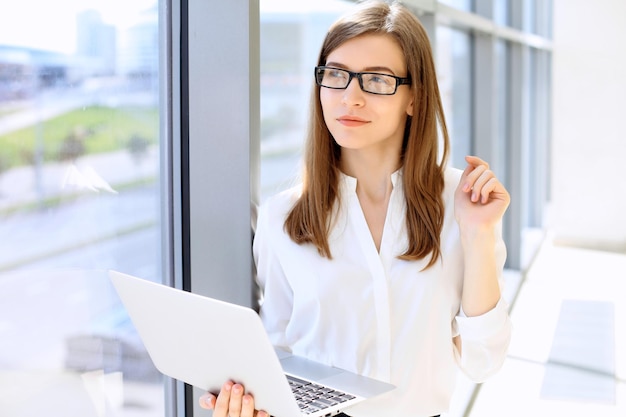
[200,2,510,417]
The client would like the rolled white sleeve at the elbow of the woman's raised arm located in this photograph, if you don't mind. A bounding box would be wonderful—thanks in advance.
[453,225,512,383]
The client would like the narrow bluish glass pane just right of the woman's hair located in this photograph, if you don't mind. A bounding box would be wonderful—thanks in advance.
[436,26,472,169]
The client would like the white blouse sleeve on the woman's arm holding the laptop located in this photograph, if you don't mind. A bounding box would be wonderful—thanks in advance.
[252,200,293,351]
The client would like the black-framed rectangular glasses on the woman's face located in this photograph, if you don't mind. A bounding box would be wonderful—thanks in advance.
[315,66,411,96]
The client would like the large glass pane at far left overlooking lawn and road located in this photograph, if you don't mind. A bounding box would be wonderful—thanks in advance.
[0,0,164,417]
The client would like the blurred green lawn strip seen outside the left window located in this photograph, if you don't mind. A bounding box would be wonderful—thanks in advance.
[0,106,158,170]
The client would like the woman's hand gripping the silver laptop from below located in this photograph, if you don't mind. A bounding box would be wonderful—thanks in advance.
[199,381,269,417]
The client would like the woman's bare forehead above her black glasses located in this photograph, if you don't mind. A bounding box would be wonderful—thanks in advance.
[326,34,406,74]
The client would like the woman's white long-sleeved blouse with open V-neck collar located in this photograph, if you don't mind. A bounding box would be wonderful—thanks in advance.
[254,168,511,417]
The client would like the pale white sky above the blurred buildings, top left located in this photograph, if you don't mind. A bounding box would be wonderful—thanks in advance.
[0,0,157,54]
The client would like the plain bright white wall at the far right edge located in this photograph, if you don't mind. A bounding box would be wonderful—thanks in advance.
[549,0,626,251]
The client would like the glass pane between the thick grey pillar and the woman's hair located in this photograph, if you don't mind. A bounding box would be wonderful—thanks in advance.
[260,0,354,199]
